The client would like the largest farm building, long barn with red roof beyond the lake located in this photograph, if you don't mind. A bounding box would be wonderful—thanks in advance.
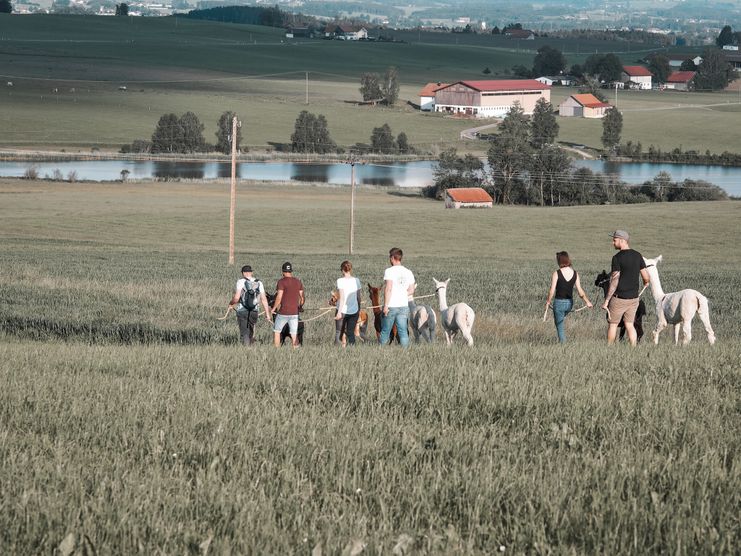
[434,79,551,118]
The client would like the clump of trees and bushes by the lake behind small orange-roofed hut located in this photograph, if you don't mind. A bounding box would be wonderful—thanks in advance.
[424,99,727,206]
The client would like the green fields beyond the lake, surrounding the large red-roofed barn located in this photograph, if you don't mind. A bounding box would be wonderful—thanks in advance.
[0,14,741,155]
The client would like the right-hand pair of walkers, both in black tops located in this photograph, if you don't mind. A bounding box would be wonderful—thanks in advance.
[546,230,649,346]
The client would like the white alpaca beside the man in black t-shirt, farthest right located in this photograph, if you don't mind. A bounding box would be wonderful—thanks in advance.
[643,255,715,345]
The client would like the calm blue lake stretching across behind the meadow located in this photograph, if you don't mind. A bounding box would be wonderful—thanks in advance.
[0,160,741,196]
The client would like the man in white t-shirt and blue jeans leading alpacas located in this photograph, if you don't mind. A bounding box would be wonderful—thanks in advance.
[378,247,414,347]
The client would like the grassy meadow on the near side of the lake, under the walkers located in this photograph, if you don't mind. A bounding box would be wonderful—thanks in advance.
[0,180,741,554]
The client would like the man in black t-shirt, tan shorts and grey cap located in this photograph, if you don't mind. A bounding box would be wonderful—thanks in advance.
[602,230,649,346]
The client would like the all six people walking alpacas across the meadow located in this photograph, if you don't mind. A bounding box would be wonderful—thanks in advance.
[229,230,649,347]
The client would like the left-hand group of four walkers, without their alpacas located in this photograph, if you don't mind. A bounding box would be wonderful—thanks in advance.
[228,247,416,347]
